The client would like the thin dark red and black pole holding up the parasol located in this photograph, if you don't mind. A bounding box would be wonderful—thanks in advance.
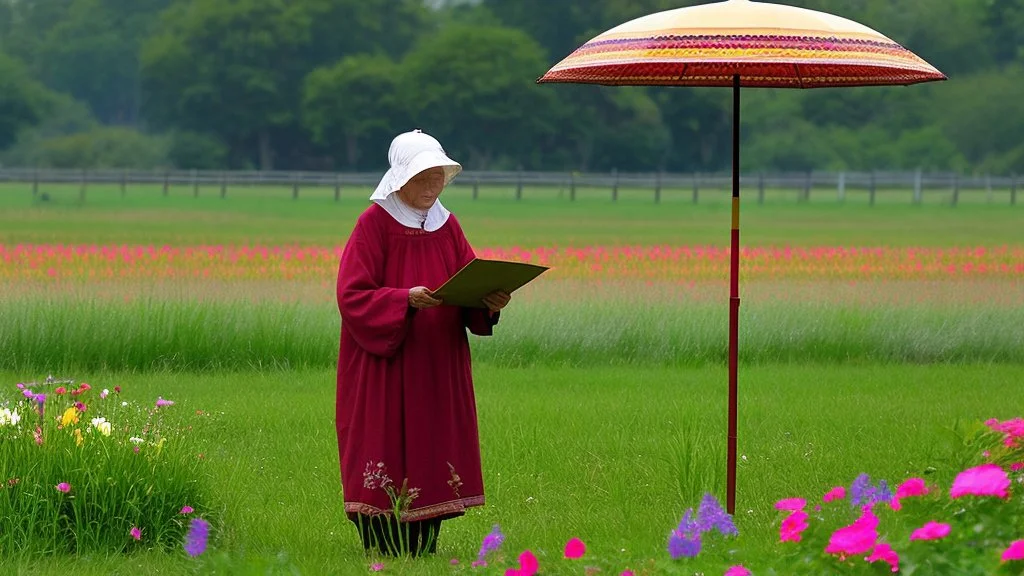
[725,74,739,515]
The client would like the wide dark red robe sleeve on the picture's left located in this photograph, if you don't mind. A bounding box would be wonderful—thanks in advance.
[338,218,416,358]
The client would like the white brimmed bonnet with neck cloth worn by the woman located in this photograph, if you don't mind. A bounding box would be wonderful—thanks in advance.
[370,130,462,232]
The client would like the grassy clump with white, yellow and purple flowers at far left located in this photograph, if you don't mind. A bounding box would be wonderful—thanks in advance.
[0,377,211,556]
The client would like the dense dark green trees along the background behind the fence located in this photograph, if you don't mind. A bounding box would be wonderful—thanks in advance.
[0,0,1024,173]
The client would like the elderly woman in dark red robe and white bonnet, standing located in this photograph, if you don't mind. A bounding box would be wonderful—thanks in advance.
[337,130,509,556]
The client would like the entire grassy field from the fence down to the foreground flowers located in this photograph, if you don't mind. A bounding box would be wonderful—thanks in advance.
[0,184,1024,574]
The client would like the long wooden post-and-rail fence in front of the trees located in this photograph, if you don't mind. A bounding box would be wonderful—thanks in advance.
[0,168,1024,205]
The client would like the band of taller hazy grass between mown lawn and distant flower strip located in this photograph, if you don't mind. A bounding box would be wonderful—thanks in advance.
[0,286,1024,371]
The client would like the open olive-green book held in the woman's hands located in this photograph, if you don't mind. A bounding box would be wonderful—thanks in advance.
[434,258,548,308]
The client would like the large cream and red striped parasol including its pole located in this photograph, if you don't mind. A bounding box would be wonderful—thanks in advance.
[538,0,946,513]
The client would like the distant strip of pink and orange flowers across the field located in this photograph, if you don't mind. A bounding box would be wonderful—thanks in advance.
[0,244,1024,281]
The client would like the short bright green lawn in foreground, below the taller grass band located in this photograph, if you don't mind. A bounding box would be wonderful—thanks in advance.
[0,363,1022,575]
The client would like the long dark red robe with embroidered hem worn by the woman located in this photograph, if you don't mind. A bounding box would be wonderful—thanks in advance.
[337,204,499,522]
